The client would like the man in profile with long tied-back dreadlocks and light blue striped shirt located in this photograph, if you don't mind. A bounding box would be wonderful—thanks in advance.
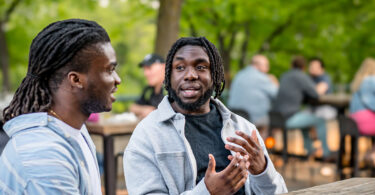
[0,19,121,194]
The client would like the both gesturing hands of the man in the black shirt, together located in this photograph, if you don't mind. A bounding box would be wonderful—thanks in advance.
[204,131,266,195]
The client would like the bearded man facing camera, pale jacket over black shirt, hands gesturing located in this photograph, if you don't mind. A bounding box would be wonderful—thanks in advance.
[124,37,287,194]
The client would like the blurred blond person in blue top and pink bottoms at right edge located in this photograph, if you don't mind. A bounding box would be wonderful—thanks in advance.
[350,58,375,166]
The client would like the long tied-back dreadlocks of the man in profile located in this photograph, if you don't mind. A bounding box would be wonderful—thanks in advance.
[3,19,110,123]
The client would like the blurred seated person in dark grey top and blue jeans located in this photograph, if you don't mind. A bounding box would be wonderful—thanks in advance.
[273,56,330,157]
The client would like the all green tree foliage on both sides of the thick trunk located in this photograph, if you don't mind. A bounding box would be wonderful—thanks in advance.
[0,0,375,97]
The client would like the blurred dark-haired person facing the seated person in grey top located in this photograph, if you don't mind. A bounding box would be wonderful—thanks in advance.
[309,57,337,120]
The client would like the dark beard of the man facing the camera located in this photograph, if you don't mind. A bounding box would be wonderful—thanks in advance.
[168,87,214,111]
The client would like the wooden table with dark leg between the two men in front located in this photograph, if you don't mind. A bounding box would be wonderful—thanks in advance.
[86,121,139,195]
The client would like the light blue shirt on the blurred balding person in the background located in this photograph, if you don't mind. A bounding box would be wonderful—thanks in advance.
[228,66,277,124]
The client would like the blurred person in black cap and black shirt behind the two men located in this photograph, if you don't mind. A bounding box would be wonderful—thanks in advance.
[130,54,165,119]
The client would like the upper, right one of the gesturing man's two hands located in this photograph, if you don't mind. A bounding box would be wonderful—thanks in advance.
[225,131,266,175]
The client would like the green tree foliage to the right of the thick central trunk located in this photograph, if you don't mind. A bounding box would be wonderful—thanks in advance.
[181,0,375,83]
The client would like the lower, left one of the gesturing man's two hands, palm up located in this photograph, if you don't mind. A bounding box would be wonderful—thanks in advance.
[204,153,248,195]
